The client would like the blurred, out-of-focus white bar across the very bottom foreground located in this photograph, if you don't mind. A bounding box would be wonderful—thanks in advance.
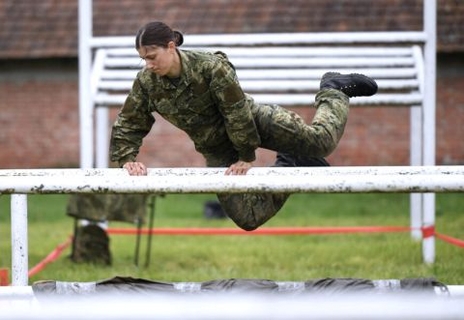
[0,289,464,320]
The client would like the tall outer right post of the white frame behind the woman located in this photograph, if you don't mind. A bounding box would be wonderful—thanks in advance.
[422,0,437,263]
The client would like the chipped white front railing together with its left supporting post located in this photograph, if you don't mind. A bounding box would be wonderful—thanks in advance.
[0,166,464,285]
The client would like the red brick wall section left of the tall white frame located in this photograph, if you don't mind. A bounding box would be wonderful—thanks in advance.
[0,81,79,168]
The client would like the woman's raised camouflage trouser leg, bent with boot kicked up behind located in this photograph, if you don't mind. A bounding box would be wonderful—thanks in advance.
[252,89,349,157]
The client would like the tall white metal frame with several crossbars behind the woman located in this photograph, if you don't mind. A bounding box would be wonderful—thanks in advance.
[74,0,437,248]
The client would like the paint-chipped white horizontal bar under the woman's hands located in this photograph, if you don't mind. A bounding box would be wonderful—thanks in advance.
[0,166,464,194]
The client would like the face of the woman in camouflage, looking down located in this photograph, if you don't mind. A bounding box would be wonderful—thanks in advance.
[137,42,176,76]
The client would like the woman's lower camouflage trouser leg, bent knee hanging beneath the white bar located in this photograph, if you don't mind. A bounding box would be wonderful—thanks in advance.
[204,148,289,231]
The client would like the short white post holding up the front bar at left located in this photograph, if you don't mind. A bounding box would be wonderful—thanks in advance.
[11,194,28,286]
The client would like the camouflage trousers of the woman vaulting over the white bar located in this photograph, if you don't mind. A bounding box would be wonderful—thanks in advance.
[203,89,349,231]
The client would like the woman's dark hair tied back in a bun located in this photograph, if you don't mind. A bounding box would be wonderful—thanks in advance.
[135,21,184,50]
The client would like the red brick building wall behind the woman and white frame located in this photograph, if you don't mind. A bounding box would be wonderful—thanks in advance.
[0,55,464,168]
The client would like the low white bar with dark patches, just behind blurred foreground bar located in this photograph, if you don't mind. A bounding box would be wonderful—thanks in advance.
[32,277,448,296]
